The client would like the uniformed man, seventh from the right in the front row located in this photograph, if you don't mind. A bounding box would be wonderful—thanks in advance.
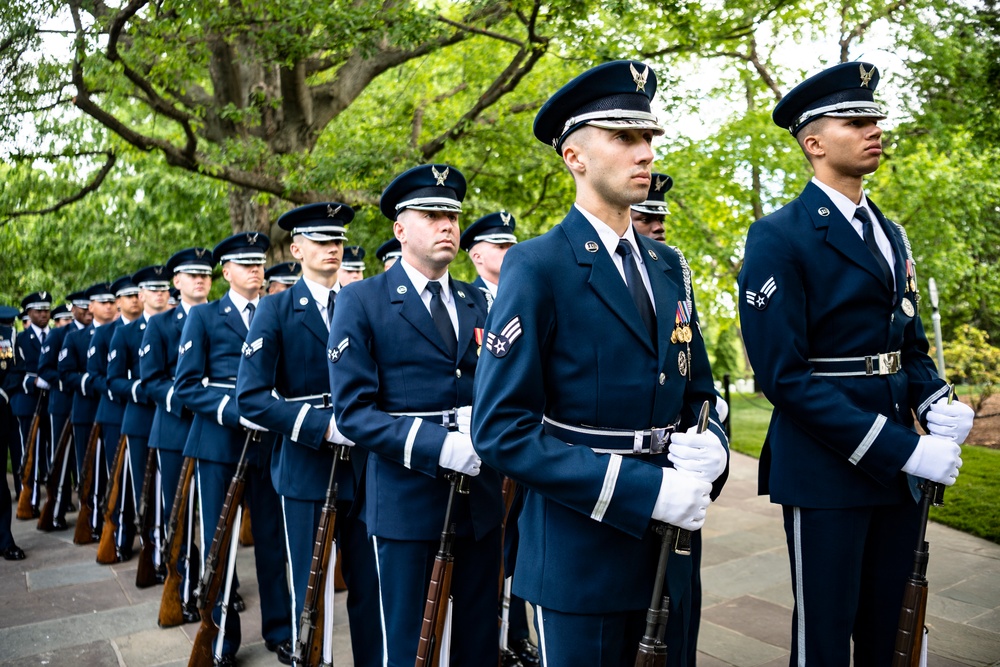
[108,265,170,551]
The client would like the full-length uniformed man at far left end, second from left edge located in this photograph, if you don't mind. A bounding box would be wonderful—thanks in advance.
[4,292,52,517]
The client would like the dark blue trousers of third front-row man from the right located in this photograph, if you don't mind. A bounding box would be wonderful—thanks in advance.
[373,527,501,667]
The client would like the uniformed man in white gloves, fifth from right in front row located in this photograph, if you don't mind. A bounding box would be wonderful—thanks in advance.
[174,232,292,665]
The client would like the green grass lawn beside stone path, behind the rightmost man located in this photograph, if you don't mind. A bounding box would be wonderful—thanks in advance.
[730,394,1000,544]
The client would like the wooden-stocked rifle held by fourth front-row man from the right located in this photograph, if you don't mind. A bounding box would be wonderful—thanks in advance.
[295,445,350,667]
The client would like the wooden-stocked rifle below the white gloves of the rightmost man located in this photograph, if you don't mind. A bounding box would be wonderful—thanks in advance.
[892,480,944,667]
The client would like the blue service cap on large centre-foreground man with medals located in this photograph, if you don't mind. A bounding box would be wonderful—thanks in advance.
[533,60,663,154]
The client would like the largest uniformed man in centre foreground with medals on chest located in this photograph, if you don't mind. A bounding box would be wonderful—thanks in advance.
[472,61,728,667]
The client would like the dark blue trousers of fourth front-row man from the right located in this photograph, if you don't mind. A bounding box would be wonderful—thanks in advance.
[281,497,382,667]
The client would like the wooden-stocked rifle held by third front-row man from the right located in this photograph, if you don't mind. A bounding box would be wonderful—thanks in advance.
[414,473,469,667]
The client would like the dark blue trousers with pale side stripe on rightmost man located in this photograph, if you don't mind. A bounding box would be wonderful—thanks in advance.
[782,502,920,667]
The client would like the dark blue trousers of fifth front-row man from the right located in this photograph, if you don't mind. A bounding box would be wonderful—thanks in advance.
[196,460,292,655]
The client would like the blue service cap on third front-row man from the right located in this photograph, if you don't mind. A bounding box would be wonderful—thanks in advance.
[379,164,466,220]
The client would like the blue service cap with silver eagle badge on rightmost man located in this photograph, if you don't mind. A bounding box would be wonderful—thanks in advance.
[771,62,886,136]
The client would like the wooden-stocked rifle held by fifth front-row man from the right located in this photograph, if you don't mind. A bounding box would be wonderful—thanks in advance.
[188,431,260,667]
